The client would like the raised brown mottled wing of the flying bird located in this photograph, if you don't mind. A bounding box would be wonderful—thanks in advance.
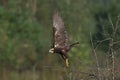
[53,12,67,48]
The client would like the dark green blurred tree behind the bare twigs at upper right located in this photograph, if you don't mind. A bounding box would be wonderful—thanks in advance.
[93,0,120,52]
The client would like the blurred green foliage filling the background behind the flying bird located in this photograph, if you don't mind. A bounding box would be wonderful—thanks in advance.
[0,0,120,80]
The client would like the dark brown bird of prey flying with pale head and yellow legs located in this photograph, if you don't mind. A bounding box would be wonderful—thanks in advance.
[49,11,79,67]
